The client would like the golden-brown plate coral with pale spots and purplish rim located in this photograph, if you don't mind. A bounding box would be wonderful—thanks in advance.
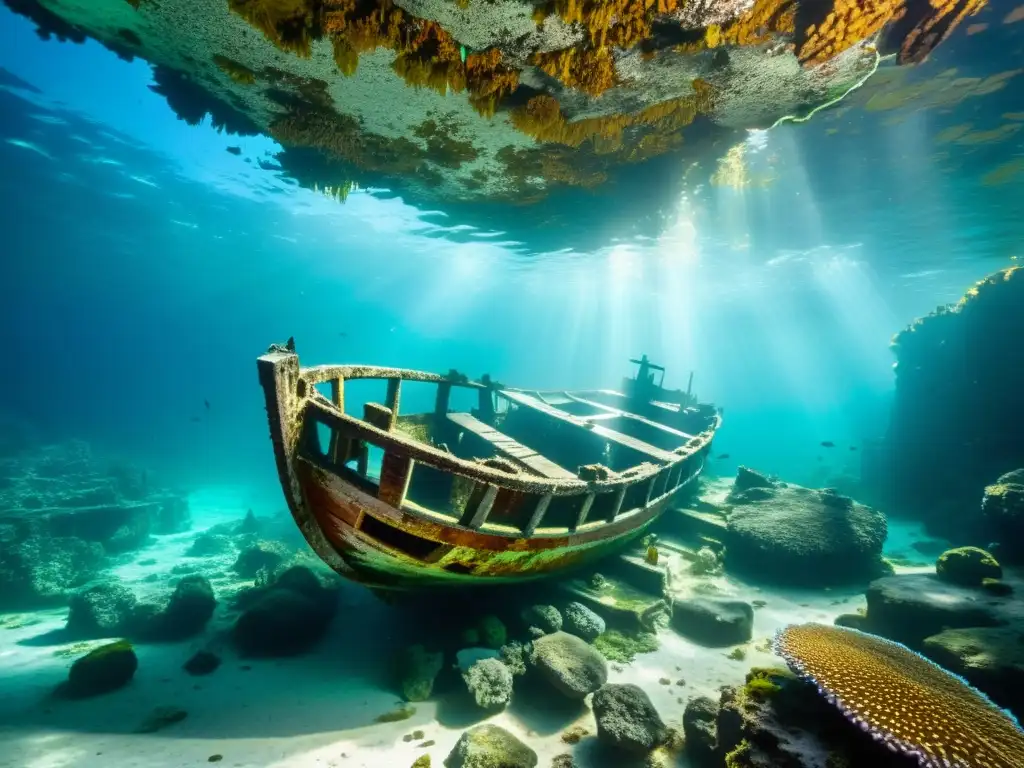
[775,624,1024,768]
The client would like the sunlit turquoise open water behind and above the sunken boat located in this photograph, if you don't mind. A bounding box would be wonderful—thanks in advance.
[0,13,1024,493]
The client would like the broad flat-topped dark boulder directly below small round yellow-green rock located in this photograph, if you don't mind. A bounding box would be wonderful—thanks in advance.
[865,573,1024,650]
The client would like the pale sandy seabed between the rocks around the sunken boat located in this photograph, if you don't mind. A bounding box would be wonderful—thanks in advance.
[0,494,932,768]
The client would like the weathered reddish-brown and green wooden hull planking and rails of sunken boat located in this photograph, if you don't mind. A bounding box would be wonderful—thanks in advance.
[259,350,719,589]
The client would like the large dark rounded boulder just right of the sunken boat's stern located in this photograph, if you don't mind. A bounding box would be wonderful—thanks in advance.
[725,478,887,587]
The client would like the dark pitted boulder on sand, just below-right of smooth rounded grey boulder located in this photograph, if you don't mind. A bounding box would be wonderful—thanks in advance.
[593,684,669,755]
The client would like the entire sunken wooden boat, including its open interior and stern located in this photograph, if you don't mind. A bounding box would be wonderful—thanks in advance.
[258,340,721,589]
